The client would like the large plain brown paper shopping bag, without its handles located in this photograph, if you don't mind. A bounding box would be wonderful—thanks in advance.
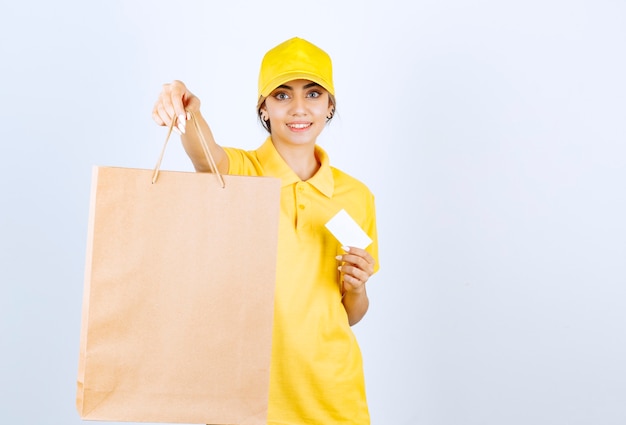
[76,167,280,425]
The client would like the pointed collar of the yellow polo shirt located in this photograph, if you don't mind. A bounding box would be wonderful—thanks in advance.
[257,137,335,198]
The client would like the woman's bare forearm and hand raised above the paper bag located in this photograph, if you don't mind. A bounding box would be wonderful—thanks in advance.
[152,81,228,174]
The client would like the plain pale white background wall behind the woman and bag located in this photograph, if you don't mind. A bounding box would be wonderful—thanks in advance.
[0,0,626,425]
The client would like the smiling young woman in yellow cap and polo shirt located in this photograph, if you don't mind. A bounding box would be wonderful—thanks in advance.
[153,38,378,425]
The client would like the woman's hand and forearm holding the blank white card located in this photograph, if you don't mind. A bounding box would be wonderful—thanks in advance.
[337,247,375,326]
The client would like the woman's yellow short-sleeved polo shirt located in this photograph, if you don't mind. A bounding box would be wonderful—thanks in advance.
[226,138,378,425]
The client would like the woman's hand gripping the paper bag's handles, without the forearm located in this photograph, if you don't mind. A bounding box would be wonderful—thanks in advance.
[152,80,200,134]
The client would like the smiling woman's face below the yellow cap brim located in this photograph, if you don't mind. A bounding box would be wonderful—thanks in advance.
[261,80,333,145]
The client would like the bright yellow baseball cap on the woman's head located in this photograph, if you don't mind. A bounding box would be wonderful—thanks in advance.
[259,37,335,98]
